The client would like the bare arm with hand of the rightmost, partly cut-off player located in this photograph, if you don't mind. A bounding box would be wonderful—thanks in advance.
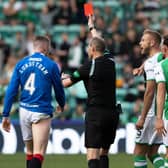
[155,82,167,135]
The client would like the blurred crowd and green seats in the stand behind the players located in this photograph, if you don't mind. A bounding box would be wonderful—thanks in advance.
[0,0,168,124]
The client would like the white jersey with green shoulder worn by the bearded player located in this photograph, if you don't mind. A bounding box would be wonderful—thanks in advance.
[144,52,163,117]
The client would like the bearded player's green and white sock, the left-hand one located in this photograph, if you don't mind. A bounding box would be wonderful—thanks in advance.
[134,156,147,168]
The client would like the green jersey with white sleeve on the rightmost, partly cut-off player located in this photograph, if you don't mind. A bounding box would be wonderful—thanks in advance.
[155,58,168,120]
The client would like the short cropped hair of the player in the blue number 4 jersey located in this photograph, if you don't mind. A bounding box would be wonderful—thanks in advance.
[33,36,50,48]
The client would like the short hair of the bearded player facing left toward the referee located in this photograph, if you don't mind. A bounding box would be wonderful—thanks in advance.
[143,29,162,45]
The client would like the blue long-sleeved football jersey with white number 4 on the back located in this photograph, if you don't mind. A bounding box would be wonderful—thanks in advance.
[3,53,65,117]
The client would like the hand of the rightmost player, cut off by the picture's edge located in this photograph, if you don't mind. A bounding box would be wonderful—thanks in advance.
[155,118,167,136]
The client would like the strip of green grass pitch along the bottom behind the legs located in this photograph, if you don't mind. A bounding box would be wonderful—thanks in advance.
[0,153,152,168]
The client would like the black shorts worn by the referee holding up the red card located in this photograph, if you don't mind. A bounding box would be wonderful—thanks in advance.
[85,107,119,149]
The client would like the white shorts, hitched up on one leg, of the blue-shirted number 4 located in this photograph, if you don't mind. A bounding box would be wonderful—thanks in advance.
[19,108,51,141]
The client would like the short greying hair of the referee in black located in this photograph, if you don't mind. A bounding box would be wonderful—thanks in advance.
[89,37,105,53]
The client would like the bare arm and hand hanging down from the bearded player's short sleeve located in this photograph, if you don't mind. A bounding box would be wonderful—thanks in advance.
[136,80,156,129]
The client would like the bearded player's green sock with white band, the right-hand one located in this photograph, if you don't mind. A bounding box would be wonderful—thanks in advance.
[151,154,164,168]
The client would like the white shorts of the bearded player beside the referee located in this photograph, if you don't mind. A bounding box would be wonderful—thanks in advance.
[135,116,163,145]
